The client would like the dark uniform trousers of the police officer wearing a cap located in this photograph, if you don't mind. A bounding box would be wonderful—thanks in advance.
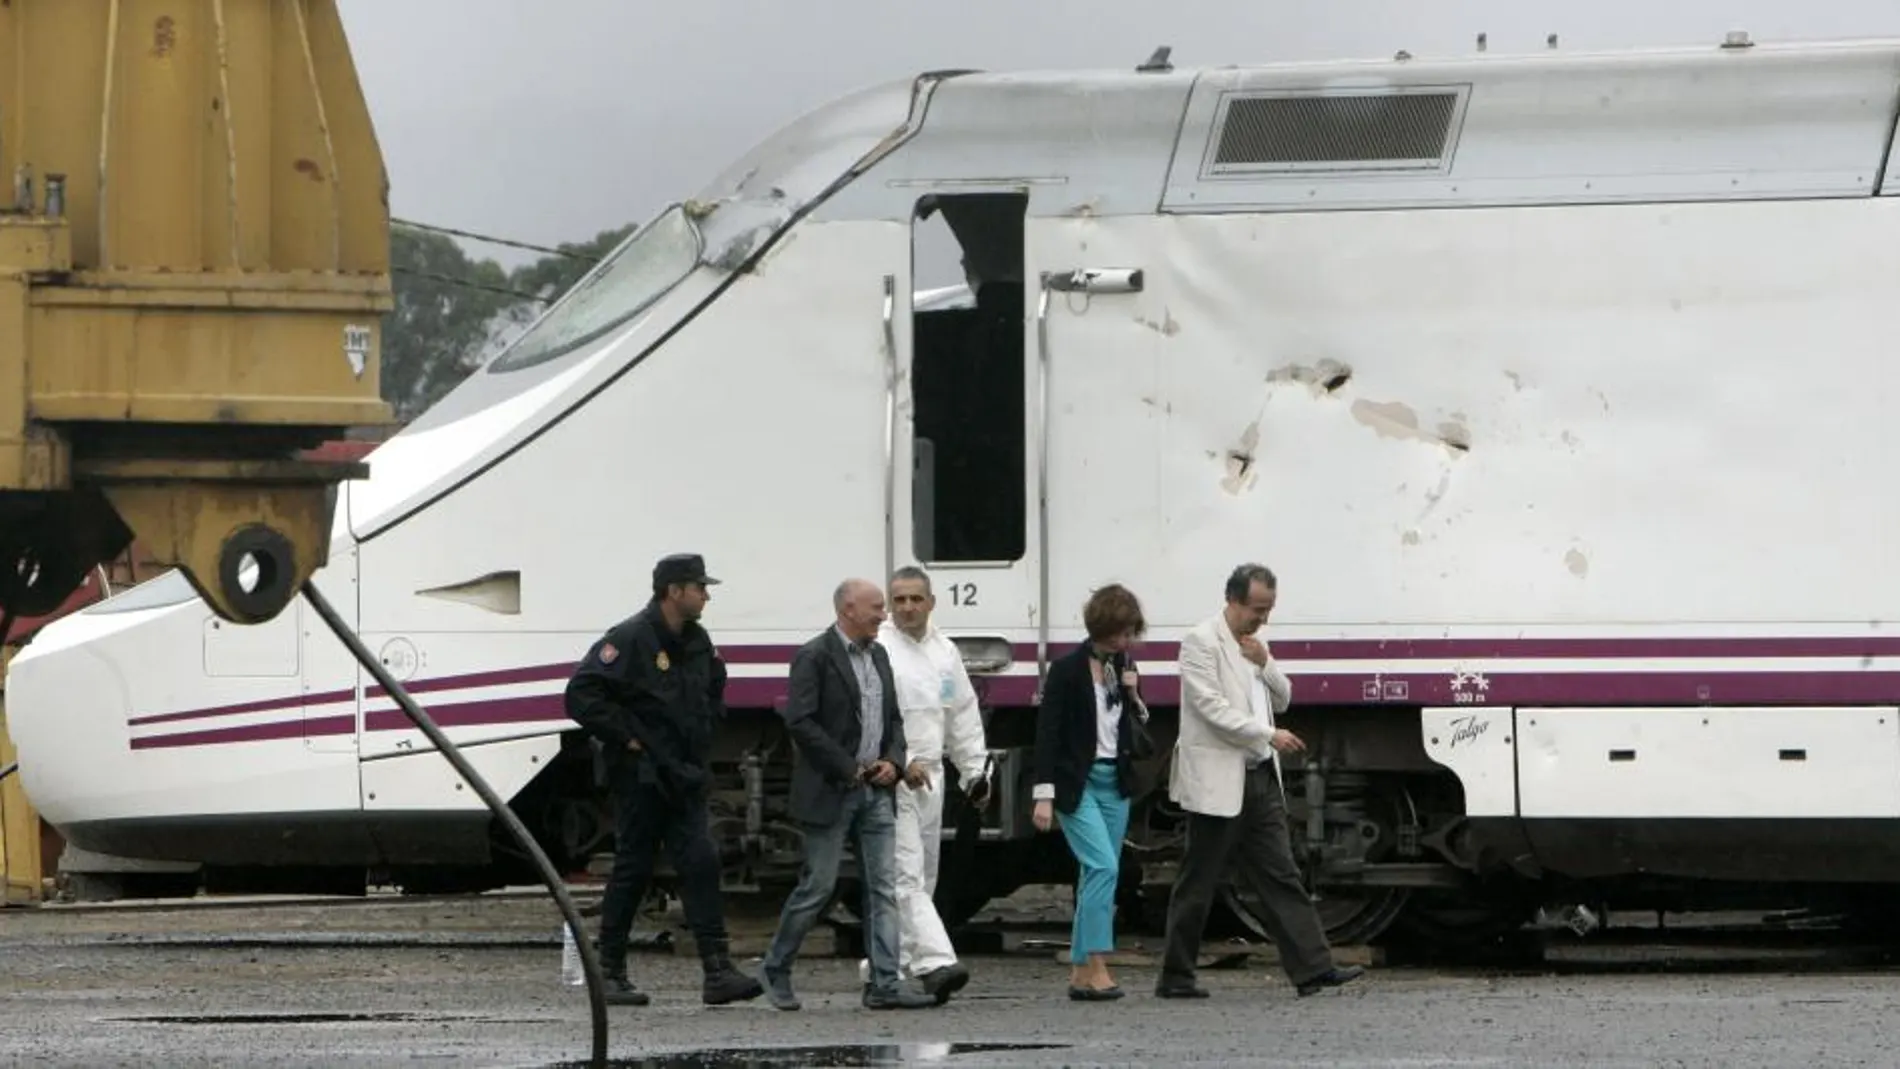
[600,773,726,976]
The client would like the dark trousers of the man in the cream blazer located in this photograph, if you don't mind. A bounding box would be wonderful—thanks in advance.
[1161,761,1332,984]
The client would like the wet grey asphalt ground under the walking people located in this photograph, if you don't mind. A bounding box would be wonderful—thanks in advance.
[0,894,1900,1067]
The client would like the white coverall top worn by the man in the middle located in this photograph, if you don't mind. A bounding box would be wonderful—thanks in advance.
[878,621,990,782]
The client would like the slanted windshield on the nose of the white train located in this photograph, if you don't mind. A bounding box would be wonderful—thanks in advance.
[488,205,703,374]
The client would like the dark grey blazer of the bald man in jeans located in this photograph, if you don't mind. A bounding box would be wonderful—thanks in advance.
[785,627,906,824]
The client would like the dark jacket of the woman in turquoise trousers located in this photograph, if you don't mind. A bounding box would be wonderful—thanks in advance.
[1036,642,1146,813]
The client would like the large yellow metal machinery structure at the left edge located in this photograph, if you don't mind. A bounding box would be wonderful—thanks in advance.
[0,0,391,623]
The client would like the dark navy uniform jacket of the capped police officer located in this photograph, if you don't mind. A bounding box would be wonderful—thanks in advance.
[566,602,726,794]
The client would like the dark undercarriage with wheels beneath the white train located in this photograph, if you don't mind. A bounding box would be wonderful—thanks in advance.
[85,708,1900,955]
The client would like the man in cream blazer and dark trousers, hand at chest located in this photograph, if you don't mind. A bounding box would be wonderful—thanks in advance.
[1155,564,1364,999]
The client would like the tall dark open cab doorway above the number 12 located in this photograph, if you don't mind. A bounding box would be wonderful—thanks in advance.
[910,194,1030,564]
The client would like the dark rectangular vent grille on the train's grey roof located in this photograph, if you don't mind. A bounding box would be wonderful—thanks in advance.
[1208,89,1465,175]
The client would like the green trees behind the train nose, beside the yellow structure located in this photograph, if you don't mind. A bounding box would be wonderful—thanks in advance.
[382,224,635,423]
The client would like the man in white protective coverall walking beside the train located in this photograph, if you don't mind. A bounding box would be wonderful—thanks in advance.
[859,568,990,1004]
